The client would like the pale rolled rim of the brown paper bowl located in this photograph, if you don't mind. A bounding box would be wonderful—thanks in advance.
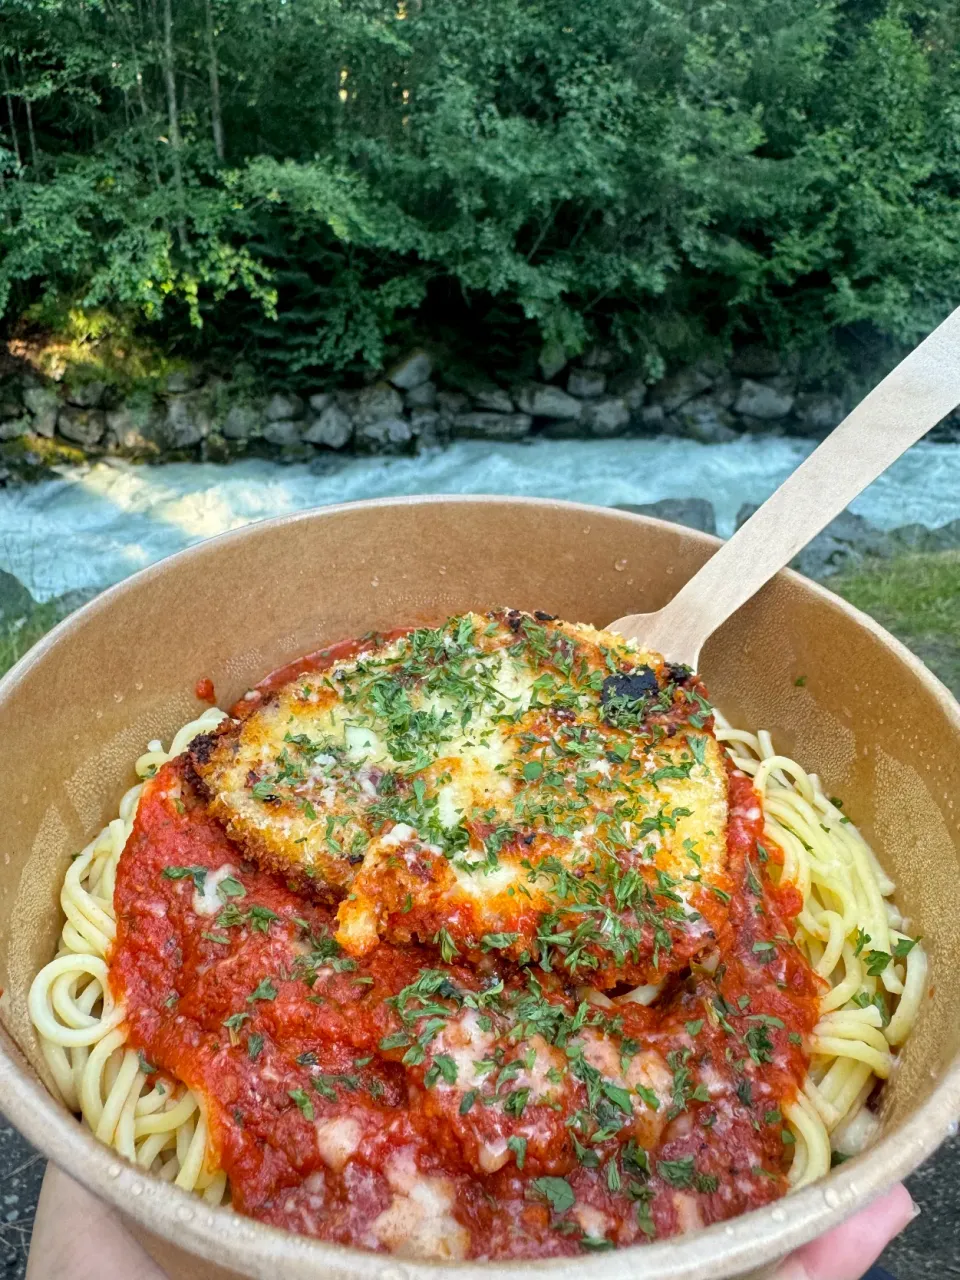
[0,494,960,1280]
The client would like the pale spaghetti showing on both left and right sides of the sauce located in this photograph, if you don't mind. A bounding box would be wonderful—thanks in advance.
[29,709,927,1204]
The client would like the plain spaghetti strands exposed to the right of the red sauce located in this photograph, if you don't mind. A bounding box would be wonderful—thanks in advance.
[717,713,927,1188]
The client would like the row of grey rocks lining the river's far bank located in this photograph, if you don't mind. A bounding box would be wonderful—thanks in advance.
[0,347,960,471]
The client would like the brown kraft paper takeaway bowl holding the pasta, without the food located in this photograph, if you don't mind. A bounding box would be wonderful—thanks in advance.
[0,498,960,1280]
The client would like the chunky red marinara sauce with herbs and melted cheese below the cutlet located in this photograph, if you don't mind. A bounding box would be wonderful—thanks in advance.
[111,752,822,1258]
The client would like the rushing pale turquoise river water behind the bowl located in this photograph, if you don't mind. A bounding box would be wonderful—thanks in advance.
[0,436,960,600]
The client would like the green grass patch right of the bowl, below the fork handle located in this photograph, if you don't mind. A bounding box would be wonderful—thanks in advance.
[826,552,960,698]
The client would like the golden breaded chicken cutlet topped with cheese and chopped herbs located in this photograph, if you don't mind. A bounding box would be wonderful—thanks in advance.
[191,609,731,989]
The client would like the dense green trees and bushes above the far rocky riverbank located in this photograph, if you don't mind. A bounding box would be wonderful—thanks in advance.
[0,0,960,379]
